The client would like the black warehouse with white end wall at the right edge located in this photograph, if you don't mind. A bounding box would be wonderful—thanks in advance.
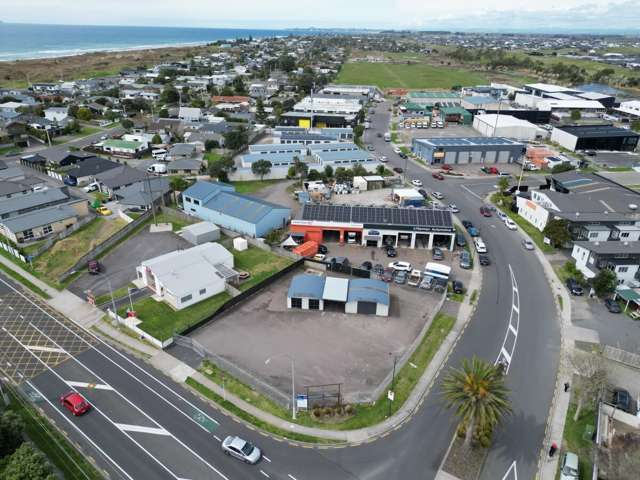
[551,124,640,152]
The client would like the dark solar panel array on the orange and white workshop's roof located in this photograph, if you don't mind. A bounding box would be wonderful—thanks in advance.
[302,204,453,228]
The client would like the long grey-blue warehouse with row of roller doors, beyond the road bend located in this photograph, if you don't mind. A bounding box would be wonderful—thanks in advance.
[411,137,525,165]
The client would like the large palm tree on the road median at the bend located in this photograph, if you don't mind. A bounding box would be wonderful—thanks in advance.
[442,357,512,447]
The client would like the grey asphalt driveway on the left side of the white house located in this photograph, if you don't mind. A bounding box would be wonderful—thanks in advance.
[69,227,192,296]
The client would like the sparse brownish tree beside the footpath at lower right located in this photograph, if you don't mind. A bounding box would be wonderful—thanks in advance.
[569,351,607,422]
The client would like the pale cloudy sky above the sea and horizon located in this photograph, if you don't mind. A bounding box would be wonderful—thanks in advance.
[0,0,640,33]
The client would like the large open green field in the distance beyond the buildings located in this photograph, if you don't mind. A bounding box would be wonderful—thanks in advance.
[336,62,487,89]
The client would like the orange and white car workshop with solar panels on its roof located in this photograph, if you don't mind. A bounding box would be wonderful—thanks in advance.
[291,204,455,250]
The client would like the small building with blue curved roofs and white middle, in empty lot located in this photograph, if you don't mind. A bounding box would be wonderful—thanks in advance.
[287,274,391,317]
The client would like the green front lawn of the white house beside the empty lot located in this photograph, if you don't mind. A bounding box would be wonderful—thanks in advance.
[118,292,231,340]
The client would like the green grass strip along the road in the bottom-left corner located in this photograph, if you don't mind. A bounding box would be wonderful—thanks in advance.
[7,394,104,480]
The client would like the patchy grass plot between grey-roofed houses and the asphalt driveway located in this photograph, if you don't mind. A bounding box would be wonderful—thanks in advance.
[33,217,127,281]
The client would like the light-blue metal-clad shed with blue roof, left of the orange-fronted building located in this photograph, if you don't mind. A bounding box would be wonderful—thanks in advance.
[182,182,291,237]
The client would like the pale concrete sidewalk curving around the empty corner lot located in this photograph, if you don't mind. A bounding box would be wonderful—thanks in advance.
[0,249,482,444]
